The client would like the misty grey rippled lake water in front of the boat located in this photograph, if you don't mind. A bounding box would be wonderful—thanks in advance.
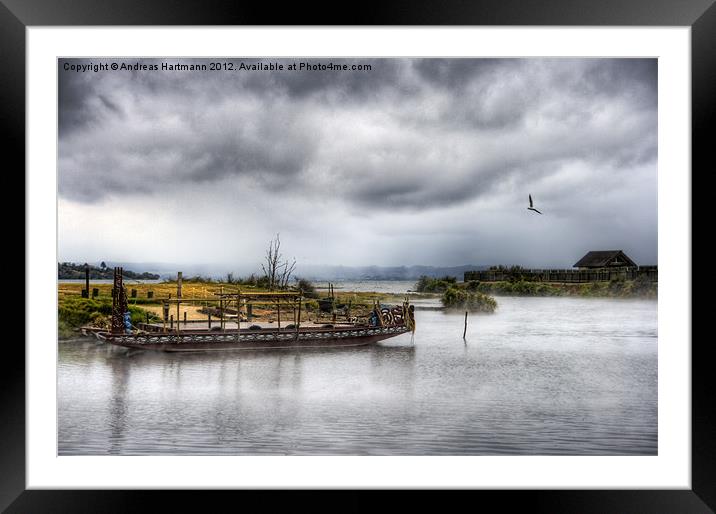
[58,283,657,455]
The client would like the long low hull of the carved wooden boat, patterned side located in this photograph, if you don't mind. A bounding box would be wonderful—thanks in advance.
[96,326,409,352]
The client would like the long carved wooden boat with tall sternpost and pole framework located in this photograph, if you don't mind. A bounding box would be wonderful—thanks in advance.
[83,268,415,352]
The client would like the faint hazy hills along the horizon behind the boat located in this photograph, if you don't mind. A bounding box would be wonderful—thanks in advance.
[60,261,489,280]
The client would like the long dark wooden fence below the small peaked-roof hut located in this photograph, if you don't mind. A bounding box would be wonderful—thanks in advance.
[464,266,659,283]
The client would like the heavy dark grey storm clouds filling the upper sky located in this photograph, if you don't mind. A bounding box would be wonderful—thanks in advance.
[59,59,656,214]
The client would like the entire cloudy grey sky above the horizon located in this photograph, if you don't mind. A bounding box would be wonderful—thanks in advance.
[58,58,657,271]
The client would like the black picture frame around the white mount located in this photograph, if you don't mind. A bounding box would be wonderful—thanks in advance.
[0,0,716,513]
